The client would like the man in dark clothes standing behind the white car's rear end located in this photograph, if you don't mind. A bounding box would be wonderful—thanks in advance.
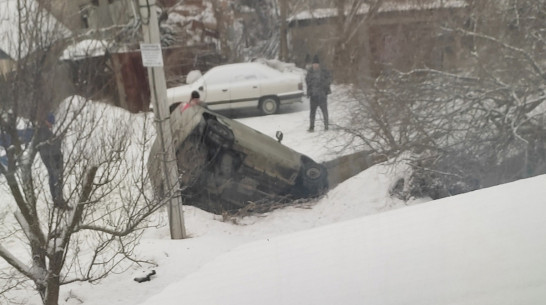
[305,55,332,132]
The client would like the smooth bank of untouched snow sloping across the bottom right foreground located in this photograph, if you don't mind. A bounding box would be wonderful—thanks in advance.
[141,176,546,305]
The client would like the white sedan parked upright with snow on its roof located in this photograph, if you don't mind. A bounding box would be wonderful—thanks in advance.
[167,62,303,114]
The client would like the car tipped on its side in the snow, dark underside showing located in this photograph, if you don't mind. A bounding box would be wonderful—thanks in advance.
[148,104,328,214]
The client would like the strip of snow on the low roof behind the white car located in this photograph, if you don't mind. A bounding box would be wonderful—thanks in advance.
[288,0,467,22]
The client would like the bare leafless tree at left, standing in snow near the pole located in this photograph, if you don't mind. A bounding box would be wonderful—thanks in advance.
[0,1,162,305]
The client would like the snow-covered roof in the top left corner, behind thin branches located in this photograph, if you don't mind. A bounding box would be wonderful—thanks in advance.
[0,0,70,59]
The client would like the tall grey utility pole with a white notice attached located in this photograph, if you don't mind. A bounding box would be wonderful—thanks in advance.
[137,0,186,239]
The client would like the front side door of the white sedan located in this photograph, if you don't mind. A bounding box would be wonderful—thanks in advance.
[203,69,231,110]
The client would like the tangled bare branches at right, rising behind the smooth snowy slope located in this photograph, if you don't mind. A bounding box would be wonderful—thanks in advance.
[338,1,546,198]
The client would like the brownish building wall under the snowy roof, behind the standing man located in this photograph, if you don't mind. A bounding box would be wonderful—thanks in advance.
[289,9,464,77]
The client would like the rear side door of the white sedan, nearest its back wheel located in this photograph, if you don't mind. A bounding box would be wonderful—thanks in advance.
[230,69,261,108]
